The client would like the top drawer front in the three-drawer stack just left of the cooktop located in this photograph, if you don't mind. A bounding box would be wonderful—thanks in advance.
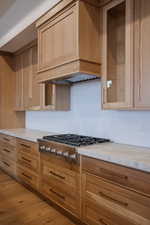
[17,139,39,156]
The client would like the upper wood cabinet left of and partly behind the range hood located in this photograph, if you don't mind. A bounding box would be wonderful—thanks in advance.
[15,44,70,111]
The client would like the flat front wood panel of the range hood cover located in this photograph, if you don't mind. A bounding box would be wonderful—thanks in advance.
[38,3,77,71]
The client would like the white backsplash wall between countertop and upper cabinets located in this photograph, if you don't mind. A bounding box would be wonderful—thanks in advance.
[26,81,150,147]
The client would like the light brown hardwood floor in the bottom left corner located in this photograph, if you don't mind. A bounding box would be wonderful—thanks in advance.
[0,170,75,225]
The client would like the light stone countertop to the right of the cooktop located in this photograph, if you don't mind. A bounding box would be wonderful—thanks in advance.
[77,142,150,172]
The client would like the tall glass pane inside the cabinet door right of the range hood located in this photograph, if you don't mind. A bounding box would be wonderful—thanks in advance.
[106,2,126,103]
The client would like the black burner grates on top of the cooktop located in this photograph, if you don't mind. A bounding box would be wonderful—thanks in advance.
[43,134,109,147]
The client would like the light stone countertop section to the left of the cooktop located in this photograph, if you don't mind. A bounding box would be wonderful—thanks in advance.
[0,128,56,142]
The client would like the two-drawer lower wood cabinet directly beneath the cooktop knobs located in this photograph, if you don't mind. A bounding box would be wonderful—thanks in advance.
[40,153,80,217]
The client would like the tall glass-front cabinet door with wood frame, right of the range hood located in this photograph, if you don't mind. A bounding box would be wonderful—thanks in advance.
[102,0,134,109]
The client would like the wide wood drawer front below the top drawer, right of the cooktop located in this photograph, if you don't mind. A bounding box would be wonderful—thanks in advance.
[83,175,150,221]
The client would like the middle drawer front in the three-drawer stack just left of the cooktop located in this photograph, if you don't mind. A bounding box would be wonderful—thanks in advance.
[17,152,39,173]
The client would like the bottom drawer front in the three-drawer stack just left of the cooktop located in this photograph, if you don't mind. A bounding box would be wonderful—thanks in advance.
[17,166,39,189]
